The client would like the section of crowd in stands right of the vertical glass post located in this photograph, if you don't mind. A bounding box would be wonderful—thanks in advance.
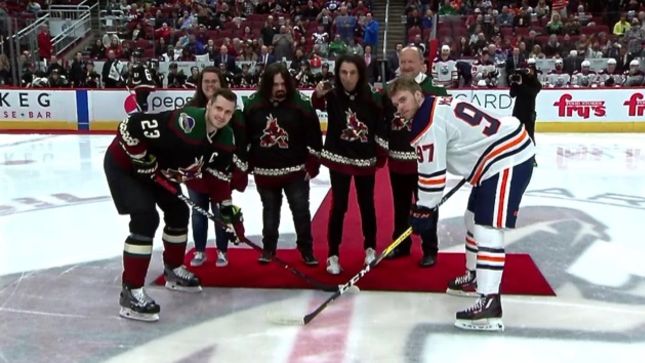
[406,0,645,87]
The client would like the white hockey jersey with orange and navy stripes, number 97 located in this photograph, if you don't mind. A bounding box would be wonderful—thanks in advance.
[410,96,535,208]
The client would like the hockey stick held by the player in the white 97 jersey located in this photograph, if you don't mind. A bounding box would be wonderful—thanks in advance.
[277,179,466,325]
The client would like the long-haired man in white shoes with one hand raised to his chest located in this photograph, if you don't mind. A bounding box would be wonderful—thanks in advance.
[311,55,387,275]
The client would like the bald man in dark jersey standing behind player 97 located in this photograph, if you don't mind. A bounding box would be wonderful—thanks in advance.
[384,46,448,267]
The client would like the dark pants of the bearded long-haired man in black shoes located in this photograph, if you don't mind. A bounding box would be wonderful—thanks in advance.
[257,179,313,251]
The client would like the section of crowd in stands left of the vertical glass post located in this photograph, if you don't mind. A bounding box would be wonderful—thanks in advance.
[2,0,380,87]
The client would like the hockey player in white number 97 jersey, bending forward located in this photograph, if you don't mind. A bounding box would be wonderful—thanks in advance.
[389,78,535,330]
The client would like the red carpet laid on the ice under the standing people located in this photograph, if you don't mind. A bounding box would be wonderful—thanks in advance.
[157,170,555,295]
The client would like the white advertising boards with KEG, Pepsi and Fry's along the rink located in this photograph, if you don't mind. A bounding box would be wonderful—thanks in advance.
[0,88,645,132]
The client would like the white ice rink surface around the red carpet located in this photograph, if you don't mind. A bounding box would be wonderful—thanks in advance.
[0,134,645,363]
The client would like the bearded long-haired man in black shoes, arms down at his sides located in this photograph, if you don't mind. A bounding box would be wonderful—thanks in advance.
[243,63,322,265]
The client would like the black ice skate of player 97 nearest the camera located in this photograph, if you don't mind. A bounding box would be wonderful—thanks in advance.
[455,294,504,331]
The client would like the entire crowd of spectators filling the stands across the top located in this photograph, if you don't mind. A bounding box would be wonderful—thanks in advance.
[0,0,645,87]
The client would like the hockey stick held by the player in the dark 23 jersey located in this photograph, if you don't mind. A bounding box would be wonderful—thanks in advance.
[154,176,338,292]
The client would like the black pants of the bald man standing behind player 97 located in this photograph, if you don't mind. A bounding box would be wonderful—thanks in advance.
[390,172,439,255]
